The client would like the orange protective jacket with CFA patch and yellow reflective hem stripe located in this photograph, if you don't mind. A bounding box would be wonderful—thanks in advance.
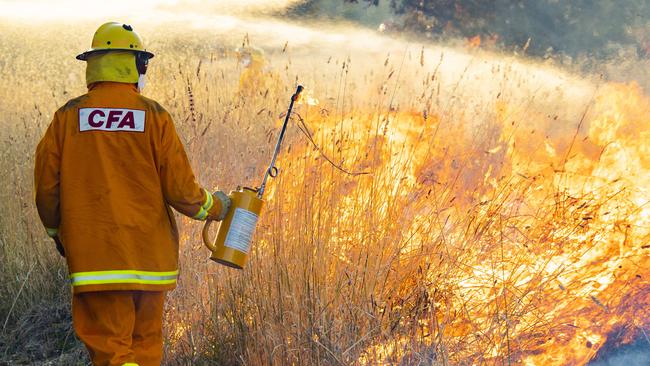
[34,82,221,293]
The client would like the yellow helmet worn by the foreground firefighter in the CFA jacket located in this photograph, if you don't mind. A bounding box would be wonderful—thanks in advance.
[77,22,153,61]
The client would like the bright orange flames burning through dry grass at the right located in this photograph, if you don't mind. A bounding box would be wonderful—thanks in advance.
[252,80,650,365]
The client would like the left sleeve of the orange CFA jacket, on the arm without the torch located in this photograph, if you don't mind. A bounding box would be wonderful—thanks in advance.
[34,113,61,237]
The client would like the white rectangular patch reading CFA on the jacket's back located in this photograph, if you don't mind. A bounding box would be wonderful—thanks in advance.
[79,108,144,132]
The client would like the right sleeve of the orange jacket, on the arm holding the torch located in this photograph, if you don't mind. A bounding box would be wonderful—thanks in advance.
[158,112,221,220]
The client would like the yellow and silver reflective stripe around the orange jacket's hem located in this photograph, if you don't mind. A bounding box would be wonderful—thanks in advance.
[70,269,178,286]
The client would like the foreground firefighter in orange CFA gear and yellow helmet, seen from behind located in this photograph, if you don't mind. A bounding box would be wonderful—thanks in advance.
[34,22,231,365]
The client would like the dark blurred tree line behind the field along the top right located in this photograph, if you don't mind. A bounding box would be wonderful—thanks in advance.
[302,0,650,57]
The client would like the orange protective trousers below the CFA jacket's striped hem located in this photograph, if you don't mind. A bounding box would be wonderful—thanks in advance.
[72,290,165,366]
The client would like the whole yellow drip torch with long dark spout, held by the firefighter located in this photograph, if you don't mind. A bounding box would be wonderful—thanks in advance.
[202,85,304,269]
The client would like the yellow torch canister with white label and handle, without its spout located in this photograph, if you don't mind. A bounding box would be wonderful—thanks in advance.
[203,188,264,269]
